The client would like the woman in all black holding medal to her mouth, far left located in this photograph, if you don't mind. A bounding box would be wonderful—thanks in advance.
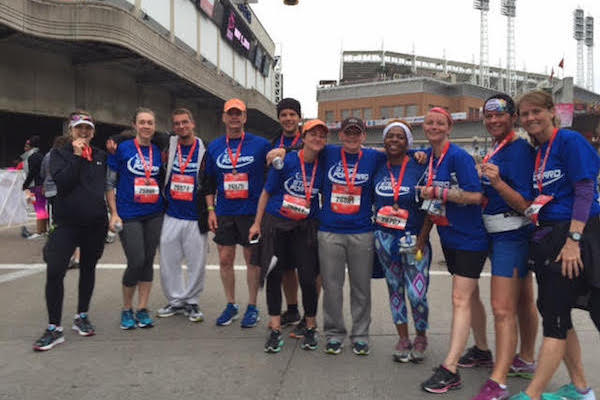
[33,111,107,351]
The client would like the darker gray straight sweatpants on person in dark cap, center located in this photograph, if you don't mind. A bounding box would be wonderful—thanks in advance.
[319,232,374,343]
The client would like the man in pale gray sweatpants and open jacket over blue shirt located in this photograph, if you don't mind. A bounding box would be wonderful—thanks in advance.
[157,108,208,322]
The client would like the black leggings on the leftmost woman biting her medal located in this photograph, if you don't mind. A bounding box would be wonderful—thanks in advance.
[44,223,107,325]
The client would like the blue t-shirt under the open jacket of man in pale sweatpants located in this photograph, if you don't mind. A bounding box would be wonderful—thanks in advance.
[165,139,202,221]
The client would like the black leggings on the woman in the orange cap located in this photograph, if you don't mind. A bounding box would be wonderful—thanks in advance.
[267,222,319,317]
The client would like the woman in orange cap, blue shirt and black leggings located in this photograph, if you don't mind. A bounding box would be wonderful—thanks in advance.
[249,120,329,353]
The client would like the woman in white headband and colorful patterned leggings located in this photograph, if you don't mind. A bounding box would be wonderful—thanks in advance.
[374,120,431,362]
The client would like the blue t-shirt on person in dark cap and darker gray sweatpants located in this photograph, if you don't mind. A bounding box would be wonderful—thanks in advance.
[319,145,386,233]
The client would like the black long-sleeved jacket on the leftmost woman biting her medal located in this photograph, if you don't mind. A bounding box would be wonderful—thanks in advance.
[50,143,107,226]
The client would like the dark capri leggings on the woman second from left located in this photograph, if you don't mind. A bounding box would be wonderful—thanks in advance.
[119,214,163,287]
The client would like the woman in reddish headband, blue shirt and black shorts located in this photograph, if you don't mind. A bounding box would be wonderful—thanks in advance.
[419,107,488,393]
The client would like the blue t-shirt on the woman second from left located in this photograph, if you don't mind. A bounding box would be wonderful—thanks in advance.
[107,139,164,221]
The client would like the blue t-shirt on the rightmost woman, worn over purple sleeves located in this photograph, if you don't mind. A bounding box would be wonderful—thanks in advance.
[533,129,600,221]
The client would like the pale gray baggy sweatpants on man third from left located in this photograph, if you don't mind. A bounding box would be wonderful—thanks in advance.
[160,215,208,307]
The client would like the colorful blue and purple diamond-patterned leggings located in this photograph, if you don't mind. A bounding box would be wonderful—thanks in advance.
[375,230,431,331]
